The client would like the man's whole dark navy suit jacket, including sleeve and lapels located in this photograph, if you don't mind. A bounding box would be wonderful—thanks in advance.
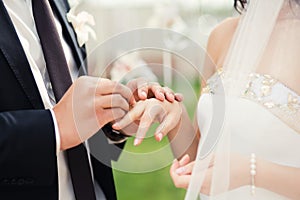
[0,0,123,200]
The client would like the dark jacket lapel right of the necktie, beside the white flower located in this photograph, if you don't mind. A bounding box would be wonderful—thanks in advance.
[50,0,87,74]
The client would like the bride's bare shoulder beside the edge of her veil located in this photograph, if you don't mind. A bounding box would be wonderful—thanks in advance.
[207,17,240,67]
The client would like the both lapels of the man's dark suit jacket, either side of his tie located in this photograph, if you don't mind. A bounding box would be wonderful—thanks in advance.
[0,0,87,109]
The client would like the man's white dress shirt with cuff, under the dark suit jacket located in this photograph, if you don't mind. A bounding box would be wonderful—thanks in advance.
[3,0,105,200]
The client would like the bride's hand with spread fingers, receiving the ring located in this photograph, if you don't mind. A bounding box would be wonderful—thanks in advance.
[113,98,182,146]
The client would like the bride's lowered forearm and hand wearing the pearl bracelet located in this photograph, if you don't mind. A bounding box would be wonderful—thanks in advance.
[170,154,300,199]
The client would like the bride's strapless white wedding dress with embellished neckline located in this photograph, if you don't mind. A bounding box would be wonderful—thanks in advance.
[197,69,300,200]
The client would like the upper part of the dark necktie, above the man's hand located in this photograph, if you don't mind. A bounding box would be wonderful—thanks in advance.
[32,0,72,102]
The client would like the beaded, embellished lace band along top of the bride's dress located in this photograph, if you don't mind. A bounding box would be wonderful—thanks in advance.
[202,69,300,133]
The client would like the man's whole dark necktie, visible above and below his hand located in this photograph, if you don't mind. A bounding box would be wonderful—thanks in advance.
[32,0,96,200]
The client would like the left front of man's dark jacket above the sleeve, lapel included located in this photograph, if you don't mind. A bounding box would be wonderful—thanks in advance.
[0,0,44,111]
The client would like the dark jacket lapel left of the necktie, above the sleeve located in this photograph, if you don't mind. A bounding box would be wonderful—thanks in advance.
[0,1,44,109]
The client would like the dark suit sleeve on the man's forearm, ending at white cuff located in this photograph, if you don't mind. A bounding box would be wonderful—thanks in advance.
[0,110,57,186]
